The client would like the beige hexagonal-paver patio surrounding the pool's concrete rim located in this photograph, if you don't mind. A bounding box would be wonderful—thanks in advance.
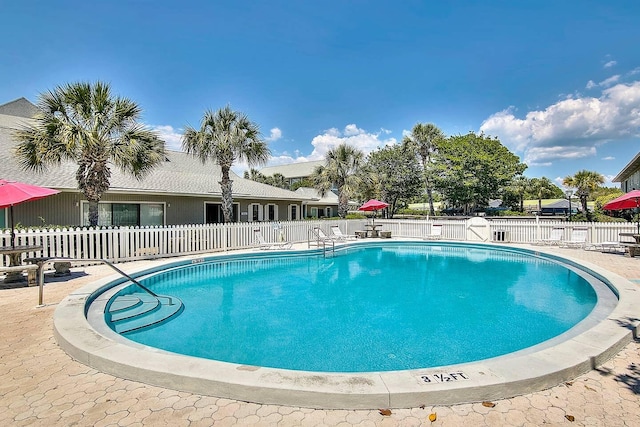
[0,249,640,427]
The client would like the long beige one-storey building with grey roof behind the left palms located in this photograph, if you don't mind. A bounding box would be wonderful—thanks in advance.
[0,98,311,227]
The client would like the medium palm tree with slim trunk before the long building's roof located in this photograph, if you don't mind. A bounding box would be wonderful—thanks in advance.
[182,105,271,222]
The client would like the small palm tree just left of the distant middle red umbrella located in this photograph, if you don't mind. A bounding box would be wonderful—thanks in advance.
[311,144,364,218]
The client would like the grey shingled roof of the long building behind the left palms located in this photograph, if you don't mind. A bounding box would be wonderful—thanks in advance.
[0,104,307,201]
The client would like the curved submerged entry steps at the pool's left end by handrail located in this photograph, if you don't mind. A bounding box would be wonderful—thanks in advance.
[107,292,184,334]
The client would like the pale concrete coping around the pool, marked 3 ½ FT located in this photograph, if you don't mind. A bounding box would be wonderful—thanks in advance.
[54,239,640,409]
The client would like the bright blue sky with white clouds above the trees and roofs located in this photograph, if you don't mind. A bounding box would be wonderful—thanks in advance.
[0,0,640,185]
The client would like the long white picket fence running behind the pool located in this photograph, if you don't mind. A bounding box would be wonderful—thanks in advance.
[0,219,637,266]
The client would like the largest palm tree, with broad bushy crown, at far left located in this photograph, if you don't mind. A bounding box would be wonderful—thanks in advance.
[14,82,165,226]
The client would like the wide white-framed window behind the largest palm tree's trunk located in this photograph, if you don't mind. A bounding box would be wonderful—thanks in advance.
[81,202,165,227]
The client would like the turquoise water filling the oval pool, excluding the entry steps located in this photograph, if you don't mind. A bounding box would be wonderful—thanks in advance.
[112,242,597,372]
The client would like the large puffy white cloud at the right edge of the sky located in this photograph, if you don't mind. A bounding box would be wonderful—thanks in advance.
[480,79,640,164]
